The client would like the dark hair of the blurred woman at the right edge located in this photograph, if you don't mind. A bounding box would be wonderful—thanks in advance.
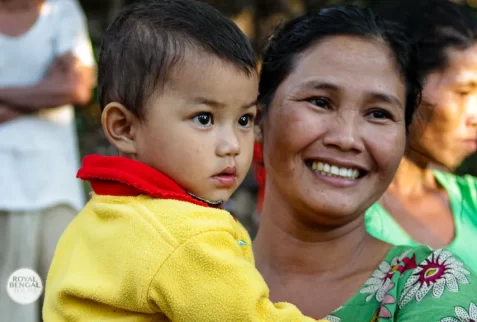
[374,0,477,77]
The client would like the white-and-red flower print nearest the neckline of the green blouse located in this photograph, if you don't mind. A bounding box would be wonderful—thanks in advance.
[359,250,409,302]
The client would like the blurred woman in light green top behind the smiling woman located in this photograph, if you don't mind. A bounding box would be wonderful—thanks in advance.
[366,0,477,272]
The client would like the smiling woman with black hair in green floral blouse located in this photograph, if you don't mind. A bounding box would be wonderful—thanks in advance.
[254,7,477,322]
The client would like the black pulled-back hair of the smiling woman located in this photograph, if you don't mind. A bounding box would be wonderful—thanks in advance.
[259,5,421,129]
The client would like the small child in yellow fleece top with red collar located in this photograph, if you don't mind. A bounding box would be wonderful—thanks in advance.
[43,0,326,322]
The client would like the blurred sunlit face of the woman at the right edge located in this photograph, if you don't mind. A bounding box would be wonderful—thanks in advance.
[409,44,477,169]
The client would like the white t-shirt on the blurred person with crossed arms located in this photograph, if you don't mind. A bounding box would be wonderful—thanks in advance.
[0,0,94,211]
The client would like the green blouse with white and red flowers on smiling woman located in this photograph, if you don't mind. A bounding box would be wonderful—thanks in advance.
[325,246,477,322]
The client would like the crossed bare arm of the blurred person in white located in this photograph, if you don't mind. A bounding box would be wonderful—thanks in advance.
[0,53,94,123]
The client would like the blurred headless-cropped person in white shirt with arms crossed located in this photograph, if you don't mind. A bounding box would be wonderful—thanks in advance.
[0,0,95,322]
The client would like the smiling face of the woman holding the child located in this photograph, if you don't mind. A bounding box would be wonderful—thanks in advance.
[263,36,406,226]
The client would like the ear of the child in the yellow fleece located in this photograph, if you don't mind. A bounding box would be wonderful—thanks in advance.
[101,102,140,156]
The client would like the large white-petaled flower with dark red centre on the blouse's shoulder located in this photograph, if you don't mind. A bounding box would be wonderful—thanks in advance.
[399,249,470,308]
